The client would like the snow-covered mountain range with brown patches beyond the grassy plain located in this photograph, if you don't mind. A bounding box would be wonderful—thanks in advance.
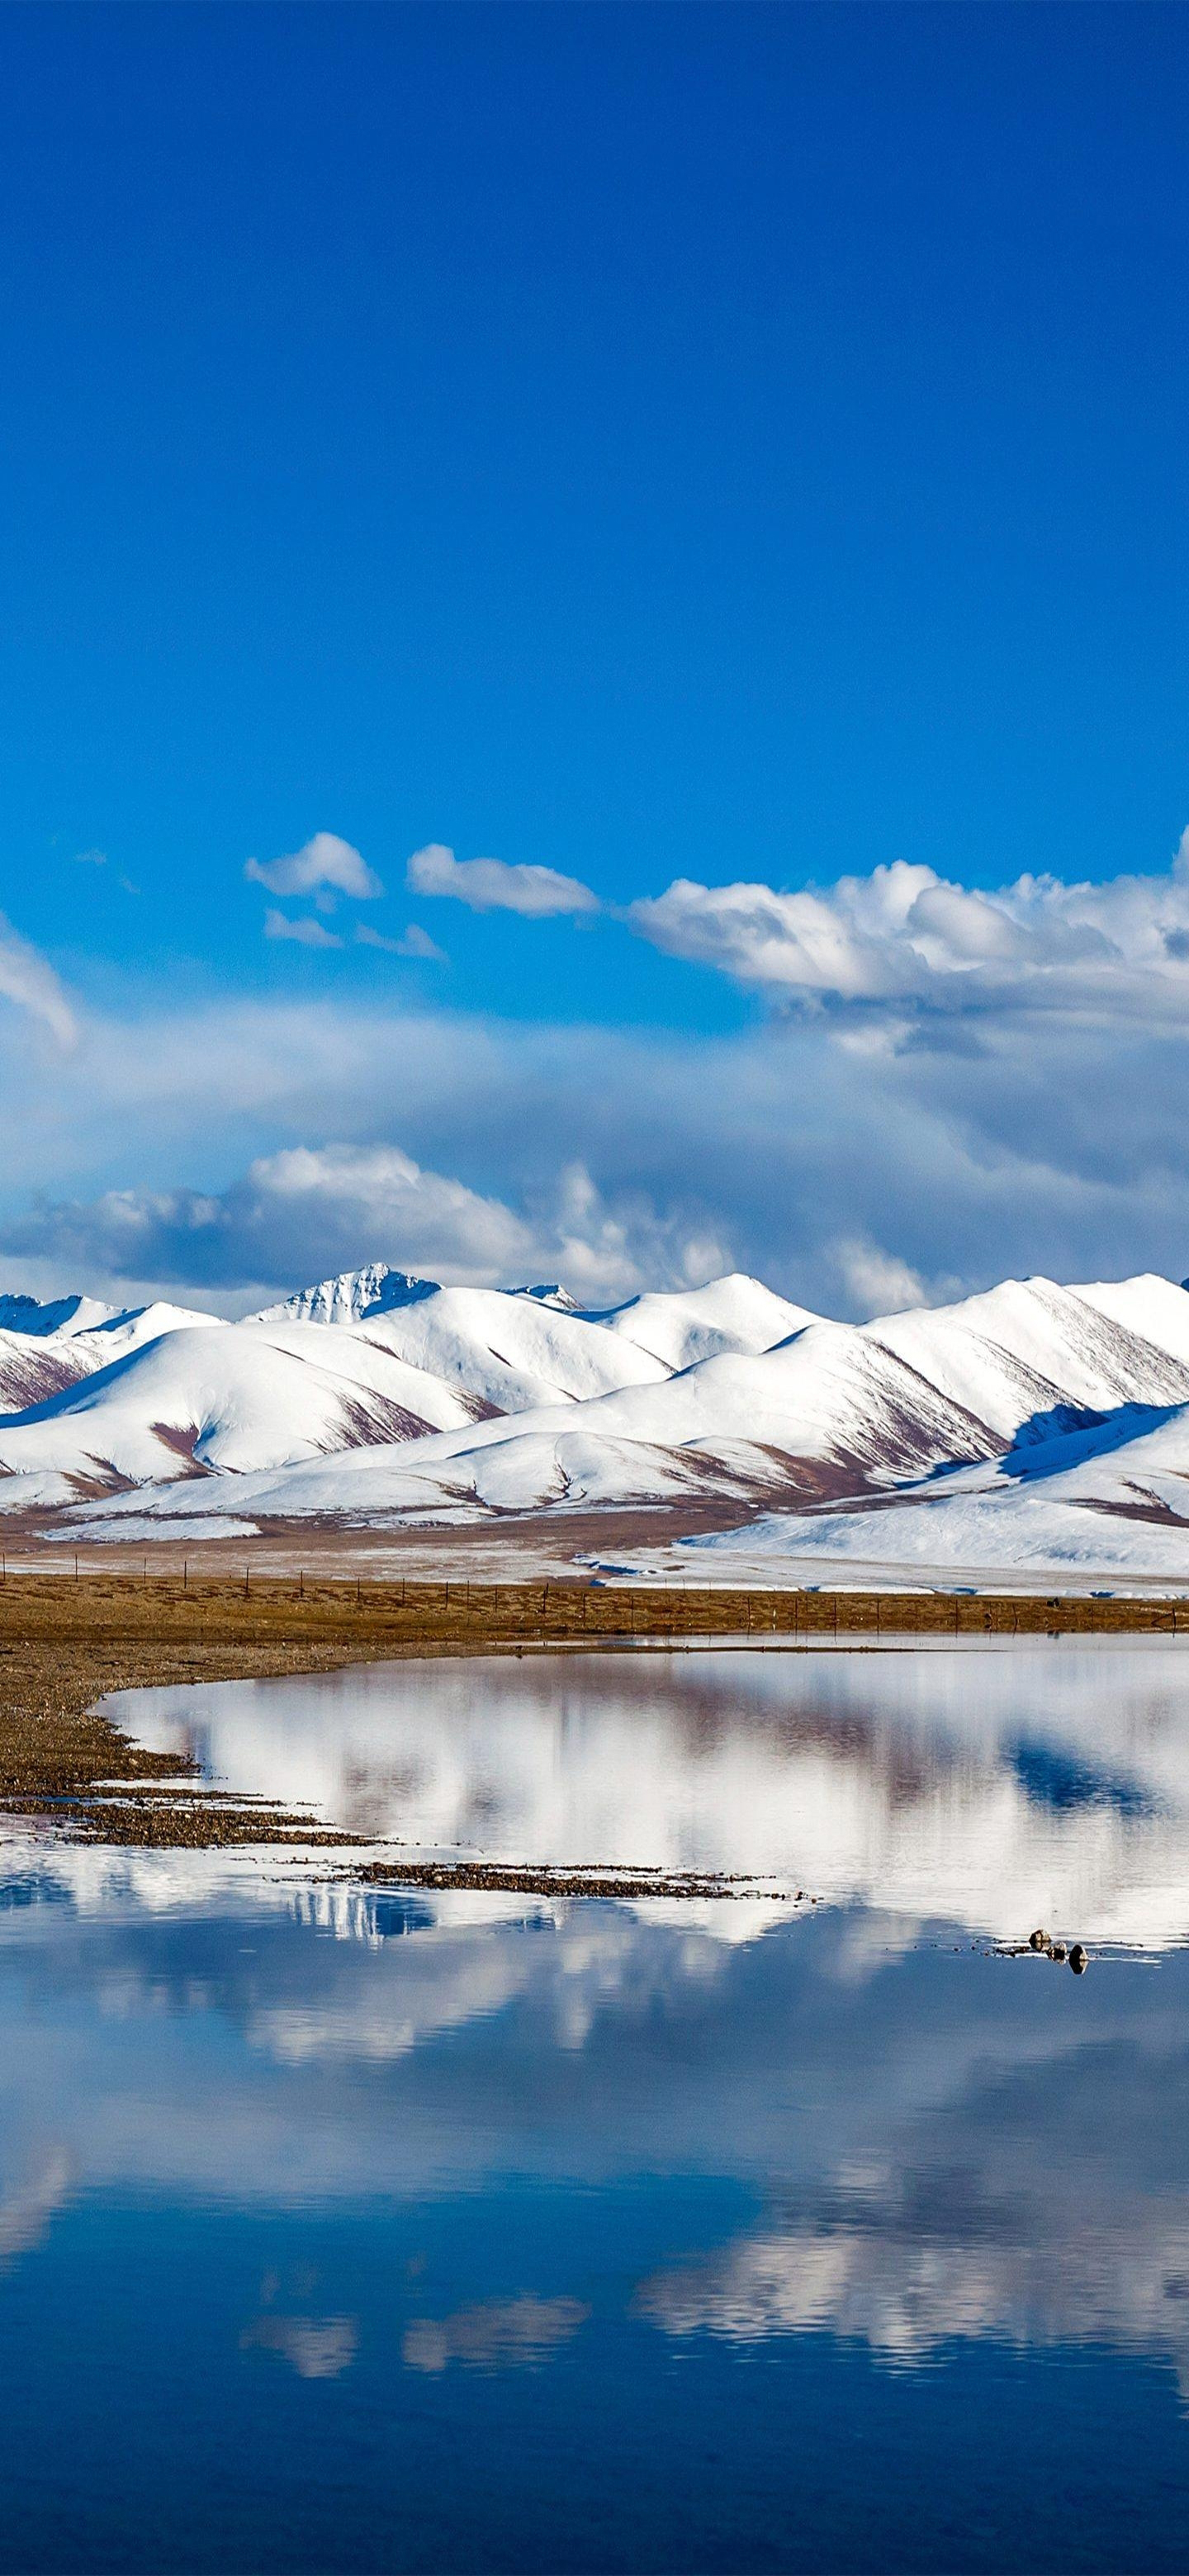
[0,1262,1189,1582]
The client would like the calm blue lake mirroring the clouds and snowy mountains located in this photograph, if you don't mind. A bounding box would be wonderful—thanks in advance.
[0,1644,1189,2576]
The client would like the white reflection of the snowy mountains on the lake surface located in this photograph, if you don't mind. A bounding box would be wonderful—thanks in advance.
[116,1638,1189,1948]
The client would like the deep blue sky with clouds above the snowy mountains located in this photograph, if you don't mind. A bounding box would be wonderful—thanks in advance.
[0,0,1189,1306]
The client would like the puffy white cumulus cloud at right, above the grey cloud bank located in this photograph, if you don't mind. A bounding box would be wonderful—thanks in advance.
[628,832,1189,1028]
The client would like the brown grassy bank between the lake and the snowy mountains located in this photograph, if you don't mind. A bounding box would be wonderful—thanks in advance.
[0,1571,1189,1844]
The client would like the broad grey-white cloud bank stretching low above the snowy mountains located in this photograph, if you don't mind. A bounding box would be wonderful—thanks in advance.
[0,824,1189,1314]
